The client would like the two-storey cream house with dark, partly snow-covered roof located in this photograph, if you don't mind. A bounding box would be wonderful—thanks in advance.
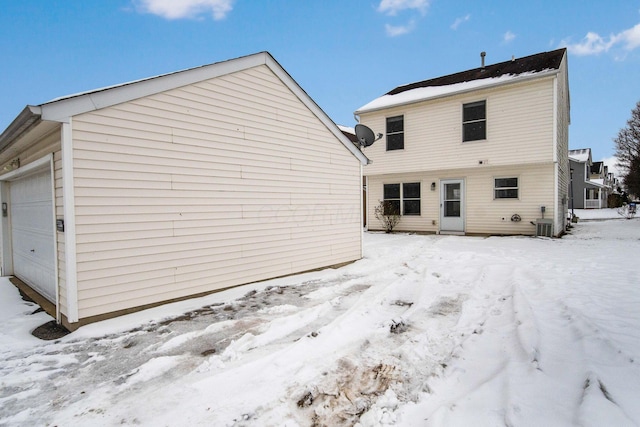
[355,49,569,241]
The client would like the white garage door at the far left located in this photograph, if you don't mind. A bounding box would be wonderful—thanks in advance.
[10,169,56,303]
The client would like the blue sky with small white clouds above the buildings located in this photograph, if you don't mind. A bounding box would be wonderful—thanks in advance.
[0,0,640,165]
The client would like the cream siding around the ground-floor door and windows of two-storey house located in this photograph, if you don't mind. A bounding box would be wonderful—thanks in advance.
[367,163,554,235]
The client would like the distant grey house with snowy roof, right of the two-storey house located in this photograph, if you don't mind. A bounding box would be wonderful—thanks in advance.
[569,148,610,209]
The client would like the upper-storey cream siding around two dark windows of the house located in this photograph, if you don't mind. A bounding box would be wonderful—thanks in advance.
[360,77,556,176]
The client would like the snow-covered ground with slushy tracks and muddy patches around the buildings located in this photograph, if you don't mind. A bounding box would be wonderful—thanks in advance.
[0,211,640,426]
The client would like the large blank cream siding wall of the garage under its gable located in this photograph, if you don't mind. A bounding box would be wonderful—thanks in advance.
[73,66,361,318]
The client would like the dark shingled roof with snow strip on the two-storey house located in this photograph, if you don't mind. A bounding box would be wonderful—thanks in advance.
[355,48,566,114]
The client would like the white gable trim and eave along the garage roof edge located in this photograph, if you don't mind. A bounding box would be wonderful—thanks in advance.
[0,52,369,164]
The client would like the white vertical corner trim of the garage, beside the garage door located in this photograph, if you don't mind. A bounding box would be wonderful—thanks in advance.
[61,117,78,323]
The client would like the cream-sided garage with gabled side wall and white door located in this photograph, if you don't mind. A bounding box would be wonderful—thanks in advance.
[0,52,367,329]
